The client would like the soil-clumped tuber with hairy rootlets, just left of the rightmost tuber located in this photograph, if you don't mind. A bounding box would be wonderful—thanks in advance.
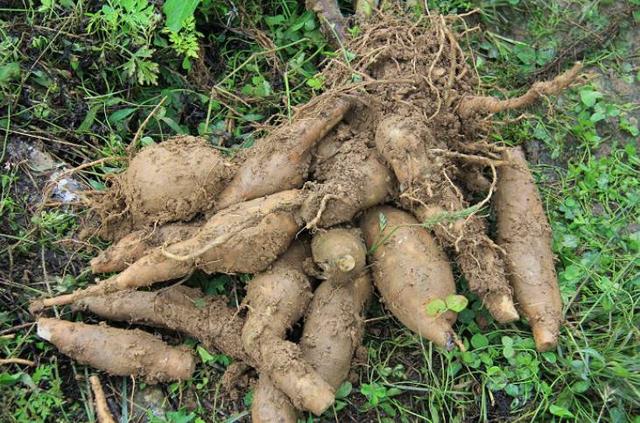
[375,116,519,323]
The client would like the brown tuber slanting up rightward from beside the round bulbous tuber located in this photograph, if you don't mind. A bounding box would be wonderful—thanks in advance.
[215,97,351,214]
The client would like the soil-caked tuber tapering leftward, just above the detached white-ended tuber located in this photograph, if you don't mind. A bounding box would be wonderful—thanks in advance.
[75,286,252,364]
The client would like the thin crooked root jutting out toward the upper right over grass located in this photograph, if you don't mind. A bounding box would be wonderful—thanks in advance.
[458,62,582,118]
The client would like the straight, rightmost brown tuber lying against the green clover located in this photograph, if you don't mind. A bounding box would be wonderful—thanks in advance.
[494,148,562,351]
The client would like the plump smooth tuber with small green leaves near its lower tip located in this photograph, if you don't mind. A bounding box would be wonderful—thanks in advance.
[361,206,456,350]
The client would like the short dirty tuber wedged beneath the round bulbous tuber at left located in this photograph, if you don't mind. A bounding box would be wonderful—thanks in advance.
[91,222,203,273]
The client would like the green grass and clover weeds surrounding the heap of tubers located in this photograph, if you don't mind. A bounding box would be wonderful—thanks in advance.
[0,0,640,422]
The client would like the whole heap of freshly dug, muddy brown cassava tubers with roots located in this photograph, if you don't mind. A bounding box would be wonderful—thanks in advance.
[31,13,580,422]
